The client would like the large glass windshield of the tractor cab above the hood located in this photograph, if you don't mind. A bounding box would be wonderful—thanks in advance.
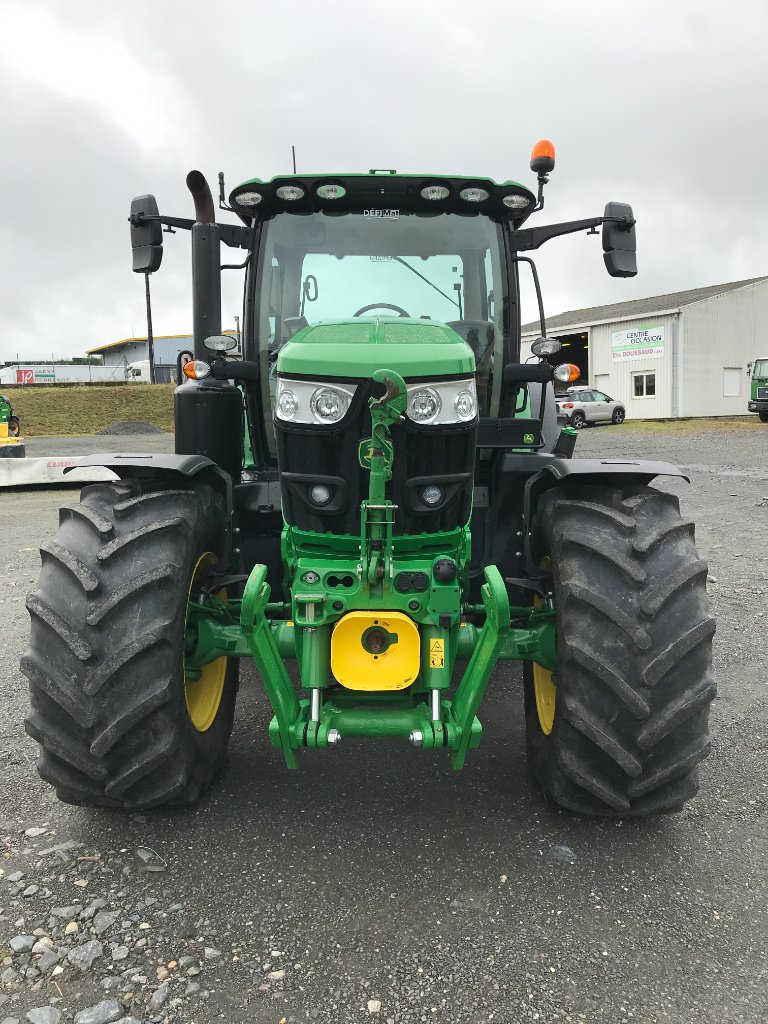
[255,210,506,440]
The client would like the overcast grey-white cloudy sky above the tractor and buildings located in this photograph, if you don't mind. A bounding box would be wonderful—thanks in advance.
[0,0,768,360]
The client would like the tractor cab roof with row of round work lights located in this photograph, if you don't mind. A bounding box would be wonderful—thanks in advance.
[229,170,536,226]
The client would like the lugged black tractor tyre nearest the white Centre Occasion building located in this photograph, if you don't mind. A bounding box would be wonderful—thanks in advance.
[524,486,716,816]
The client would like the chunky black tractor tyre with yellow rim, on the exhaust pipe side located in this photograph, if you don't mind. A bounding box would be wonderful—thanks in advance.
[22,476,238,808]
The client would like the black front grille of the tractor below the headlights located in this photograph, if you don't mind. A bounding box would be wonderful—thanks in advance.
[274,381,477,535]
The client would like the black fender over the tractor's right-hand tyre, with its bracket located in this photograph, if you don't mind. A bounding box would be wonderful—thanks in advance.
[514,454,690,575]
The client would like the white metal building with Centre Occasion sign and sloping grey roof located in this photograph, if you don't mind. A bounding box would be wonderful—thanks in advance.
[521,276,768,419]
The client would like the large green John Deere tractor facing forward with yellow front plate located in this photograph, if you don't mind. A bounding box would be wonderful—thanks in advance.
[22,142,715,816]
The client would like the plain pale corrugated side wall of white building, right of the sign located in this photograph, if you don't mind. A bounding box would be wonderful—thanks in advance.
[680,282,768,416]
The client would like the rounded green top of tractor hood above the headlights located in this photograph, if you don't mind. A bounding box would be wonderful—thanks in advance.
[278,316,475,378]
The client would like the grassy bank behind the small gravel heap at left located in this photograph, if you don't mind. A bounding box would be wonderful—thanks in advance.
[8,384,175,437]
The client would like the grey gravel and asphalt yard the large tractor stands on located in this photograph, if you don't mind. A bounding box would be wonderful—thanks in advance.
[0,423,768,1024]
